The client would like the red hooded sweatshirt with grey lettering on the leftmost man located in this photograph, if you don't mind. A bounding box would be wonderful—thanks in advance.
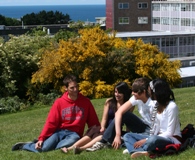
[38,92,100,141]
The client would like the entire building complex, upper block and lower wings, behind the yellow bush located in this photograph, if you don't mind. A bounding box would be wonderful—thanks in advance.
[106,0,195,87]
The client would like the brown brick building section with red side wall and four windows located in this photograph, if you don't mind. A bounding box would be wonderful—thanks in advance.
[106,0,152,32]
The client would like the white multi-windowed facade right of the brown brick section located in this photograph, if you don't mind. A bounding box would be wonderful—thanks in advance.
[152,0,195,32]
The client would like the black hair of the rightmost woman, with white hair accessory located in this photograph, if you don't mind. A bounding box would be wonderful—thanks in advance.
[150,78,175,106]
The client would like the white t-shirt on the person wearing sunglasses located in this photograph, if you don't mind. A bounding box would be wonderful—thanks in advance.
[129,96,156,127]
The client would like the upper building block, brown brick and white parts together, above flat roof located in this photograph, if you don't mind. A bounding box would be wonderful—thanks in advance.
[106,0,195,32]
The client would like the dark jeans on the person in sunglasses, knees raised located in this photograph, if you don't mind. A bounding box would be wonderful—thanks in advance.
[102,112,150,144]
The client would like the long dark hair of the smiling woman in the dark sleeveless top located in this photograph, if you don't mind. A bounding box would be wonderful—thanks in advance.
[108,82,131,112]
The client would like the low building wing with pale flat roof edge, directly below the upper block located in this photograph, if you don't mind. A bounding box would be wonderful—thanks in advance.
[116,30,195,60]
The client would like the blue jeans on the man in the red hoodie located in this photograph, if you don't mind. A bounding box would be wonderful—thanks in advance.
[22,130,80,152]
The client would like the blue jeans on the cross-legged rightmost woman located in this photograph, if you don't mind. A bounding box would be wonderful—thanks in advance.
[123,133,174,153]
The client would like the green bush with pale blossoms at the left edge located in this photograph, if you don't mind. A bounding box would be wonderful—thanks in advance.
[0,35,51,99]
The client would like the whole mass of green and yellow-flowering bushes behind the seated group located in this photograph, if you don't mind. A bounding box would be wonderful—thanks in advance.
[0,26,181,105]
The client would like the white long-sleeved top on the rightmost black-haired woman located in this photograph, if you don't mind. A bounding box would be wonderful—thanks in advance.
[156,101,181,143]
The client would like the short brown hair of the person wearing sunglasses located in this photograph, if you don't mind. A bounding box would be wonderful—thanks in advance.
[132,77,150,97]
